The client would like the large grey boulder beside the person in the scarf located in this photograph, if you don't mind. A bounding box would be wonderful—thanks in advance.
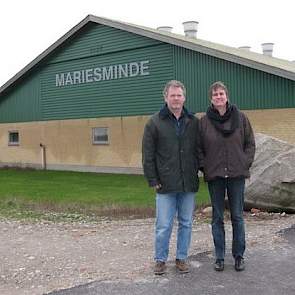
[245,133,295,212]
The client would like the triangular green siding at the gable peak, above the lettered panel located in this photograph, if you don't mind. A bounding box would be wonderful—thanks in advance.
[48,23,161,63]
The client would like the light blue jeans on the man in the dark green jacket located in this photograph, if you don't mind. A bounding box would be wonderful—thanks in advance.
[155,193,196,262]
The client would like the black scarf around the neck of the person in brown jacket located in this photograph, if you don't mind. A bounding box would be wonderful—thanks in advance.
[207,104,239,136]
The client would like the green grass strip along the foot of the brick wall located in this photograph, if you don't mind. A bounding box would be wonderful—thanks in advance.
[0,169,209,220]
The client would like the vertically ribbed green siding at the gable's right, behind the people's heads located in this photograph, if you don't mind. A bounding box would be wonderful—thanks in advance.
[173,46,295,112]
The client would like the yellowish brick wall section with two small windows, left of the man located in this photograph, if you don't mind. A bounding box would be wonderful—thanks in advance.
[0,116,147,170]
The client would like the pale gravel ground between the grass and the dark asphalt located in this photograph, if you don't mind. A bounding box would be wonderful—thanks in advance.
[0,212,295,295]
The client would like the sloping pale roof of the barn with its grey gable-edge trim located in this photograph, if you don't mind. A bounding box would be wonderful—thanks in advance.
[0,15,295,96]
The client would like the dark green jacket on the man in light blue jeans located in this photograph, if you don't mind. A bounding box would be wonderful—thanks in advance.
[142,106,199,194]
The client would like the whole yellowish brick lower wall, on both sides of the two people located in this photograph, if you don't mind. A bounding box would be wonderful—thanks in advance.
[0,109,295,173]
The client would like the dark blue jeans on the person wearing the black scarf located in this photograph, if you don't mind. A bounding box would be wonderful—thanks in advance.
[208,178,246,259]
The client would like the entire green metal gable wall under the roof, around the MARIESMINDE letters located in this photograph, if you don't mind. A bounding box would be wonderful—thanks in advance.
[0,23,295,122]
